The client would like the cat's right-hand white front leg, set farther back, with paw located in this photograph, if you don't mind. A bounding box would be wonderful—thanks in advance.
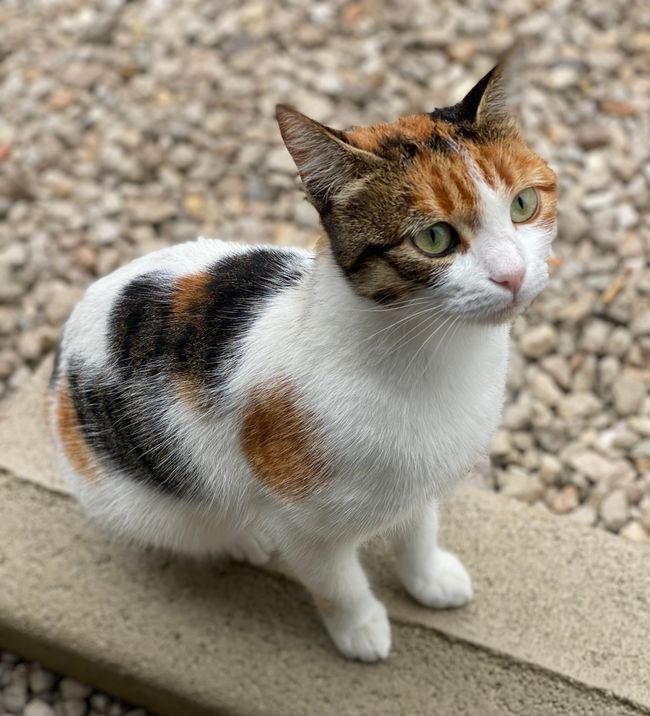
[395,503,473,609]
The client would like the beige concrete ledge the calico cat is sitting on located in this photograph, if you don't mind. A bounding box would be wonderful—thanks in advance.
[0,474,650,716]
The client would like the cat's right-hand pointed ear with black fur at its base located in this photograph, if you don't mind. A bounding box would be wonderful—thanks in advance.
[458,42,523,123]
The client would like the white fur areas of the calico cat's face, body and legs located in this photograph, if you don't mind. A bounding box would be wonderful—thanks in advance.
[52,176,550,661]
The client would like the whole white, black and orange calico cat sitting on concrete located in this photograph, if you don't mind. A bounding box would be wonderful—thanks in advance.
[50,53,556,661]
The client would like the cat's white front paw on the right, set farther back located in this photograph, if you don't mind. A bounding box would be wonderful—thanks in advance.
[401,549,474,609]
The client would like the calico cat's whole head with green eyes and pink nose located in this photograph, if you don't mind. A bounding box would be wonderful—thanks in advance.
[277,51,556,322]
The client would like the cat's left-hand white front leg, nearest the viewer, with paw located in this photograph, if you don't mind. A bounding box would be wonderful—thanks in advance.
[282,539,390,661]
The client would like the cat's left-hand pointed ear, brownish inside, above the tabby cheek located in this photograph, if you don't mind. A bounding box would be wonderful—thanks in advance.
[275,104,381,211]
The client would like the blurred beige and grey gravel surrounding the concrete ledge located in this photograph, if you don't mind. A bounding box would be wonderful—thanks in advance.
[0,0,650,716]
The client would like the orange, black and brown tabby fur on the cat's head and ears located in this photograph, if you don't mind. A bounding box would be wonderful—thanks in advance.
[277,47,556,310]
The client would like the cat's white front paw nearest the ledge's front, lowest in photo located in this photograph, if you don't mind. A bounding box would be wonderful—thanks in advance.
[324,602,390,661]
